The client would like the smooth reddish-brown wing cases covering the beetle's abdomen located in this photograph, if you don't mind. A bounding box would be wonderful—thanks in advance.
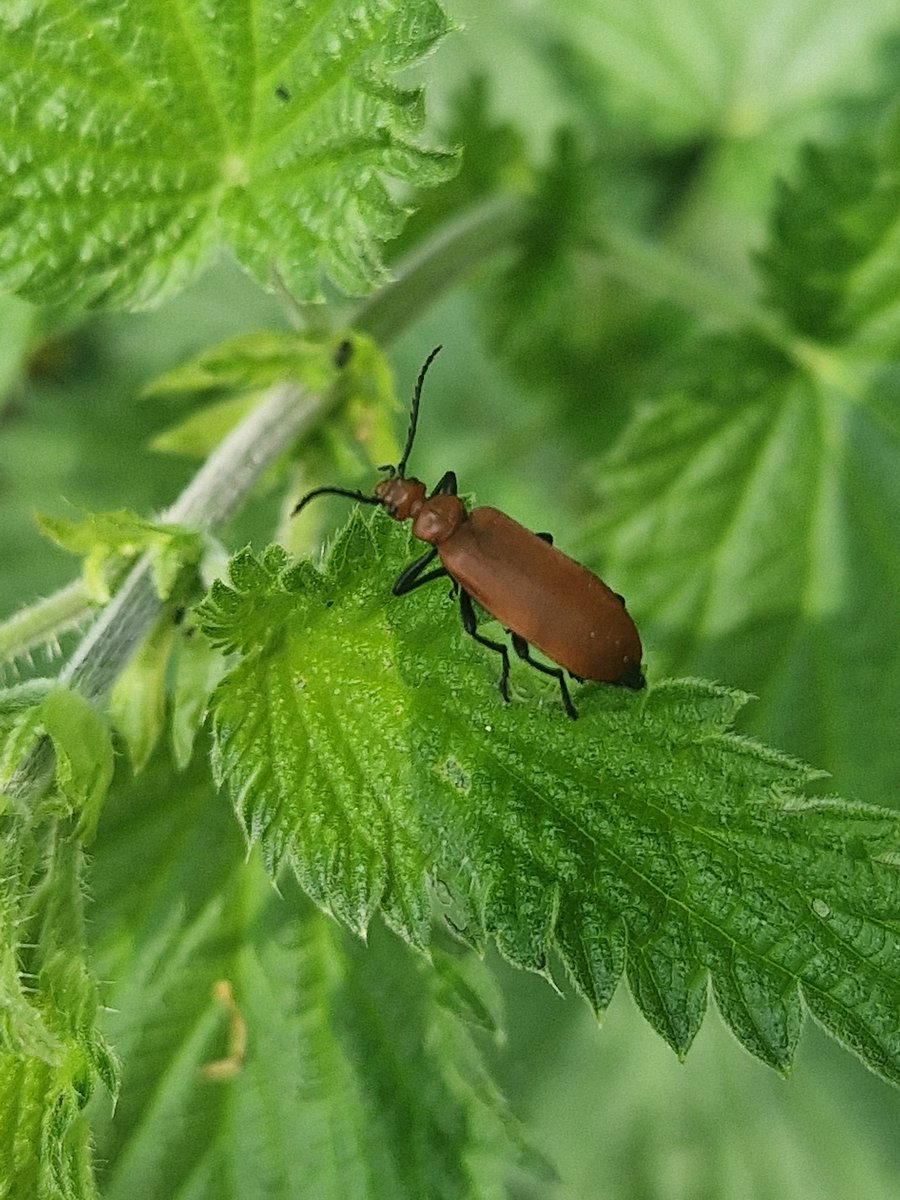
[438,508,642,686]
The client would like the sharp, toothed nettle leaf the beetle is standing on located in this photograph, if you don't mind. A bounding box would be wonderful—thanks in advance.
[200,514,900,1081]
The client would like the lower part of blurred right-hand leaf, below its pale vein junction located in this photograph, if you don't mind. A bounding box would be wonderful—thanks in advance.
[590,334,900,803]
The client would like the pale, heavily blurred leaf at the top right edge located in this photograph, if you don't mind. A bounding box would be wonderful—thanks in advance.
[545,0,895,139]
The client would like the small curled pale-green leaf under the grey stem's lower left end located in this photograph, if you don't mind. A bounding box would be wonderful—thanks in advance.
[41,688,114,841]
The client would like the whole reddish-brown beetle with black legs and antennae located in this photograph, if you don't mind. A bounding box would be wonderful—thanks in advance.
[294,346,644,720]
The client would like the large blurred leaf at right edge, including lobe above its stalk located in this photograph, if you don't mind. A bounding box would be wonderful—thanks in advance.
[592,125,900,802]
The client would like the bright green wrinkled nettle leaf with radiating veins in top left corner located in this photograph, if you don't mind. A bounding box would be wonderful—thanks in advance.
[0,0,452,306]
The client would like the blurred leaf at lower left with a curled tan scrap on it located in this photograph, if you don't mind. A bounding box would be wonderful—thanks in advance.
[86,755,535,1200]
